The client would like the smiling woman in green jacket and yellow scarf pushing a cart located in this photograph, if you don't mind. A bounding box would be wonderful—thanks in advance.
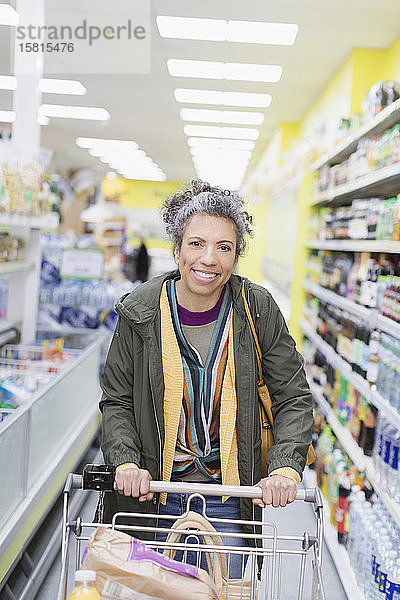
[100,180,313,572]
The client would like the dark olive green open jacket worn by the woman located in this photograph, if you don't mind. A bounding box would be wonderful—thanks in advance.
[100,271,313,525]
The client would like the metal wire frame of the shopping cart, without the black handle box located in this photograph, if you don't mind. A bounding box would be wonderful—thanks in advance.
[57,473,325,600]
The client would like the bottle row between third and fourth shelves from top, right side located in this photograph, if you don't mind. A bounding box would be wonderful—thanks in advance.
[307,251,400,322]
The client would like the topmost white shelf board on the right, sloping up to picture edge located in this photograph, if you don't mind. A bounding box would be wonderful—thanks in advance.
[310,99,400,171]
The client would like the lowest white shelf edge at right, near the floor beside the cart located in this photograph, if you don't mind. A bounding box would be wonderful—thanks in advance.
[303,467,364,600]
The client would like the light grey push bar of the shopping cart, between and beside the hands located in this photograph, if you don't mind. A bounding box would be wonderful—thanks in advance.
[64,473,322,508]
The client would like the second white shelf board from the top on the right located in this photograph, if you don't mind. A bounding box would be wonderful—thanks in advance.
[310,162,400,206]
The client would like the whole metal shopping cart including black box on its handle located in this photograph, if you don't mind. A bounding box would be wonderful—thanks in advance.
[57,465,325,600]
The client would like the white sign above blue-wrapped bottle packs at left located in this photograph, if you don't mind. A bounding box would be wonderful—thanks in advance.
[60,248,104,279]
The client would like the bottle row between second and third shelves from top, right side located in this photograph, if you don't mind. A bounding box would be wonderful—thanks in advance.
[309,194,400,242]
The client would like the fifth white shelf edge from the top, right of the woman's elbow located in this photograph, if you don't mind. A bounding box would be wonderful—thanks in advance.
[300,319,400,429]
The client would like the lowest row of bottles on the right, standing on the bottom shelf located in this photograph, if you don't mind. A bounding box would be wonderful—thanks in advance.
[316,413,400,600]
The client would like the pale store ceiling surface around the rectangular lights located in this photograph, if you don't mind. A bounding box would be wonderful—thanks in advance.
[0,0,400,185]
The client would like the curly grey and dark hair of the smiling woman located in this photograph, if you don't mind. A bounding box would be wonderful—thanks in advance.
[161,179,253,257]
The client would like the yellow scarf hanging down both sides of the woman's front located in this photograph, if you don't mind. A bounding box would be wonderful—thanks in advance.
[160,283,240,504]
